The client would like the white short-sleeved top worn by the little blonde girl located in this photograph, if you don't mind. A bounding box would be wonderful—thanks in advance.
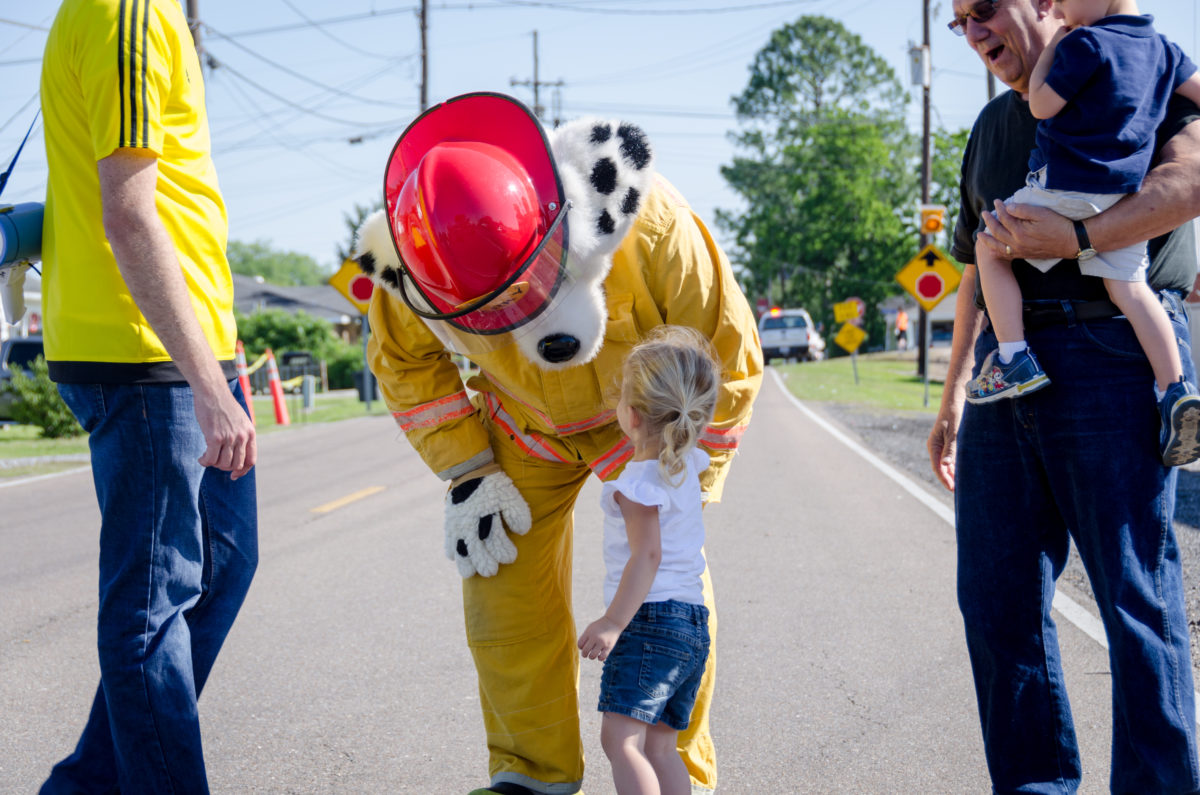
[600,448,709,606]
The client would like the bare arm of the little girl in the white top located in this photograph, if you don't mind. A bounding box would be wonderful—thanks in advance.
[578,491,662,659]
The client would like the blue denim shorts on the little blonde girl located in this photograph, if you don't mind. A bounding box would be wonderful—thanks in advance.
[599,599,708,731]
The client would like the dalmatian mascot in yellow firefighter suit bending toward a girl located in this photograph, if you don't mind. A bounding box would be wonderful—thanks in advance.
[355,92,762,795]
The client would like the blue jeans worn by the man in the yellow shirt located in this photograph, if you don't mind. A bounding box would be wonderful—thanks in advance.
[42,381,258,795]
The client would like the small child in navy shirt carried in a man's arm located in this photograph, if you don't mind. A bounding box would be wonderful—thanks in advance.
[967,0,1200,466]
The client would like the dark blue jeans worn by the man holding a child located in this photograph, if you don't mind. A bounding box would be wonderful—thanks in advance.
[955,293,1200,793]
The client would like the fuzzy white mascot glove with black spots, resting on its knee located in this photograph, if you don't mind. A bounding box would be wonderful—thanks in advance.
[445,464,533,578]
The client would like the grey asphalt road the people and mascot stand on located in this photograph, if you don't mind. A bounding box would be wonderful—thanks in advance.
[0,377,1137,795]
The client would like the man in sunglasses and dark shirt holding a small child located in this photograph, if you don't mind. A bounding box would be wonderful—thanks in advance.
[929,0,1200,793]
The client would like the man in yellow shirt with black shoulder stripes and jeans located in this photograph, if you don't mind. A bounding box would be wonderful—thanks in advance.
[41,0,258,795]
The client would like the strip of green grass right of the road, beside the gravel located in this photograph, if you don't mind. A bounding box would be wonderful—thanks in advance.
[775,353,942,413]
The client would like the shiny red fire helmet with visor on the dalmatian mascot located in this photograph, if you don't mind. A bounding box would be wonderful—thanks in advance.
[384,92,566,335]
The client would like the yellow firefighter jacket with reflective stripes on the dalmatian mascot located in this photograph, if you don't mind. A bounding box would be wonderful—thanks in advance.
[368,177,762,502]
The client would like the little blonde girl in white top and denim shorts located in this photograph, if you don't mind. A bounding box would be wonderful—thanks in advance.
[578,325,721,795]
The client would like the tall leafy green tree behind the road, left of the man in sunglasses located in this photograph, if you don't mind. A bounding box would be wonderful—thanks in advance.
[718,16,961,353]
